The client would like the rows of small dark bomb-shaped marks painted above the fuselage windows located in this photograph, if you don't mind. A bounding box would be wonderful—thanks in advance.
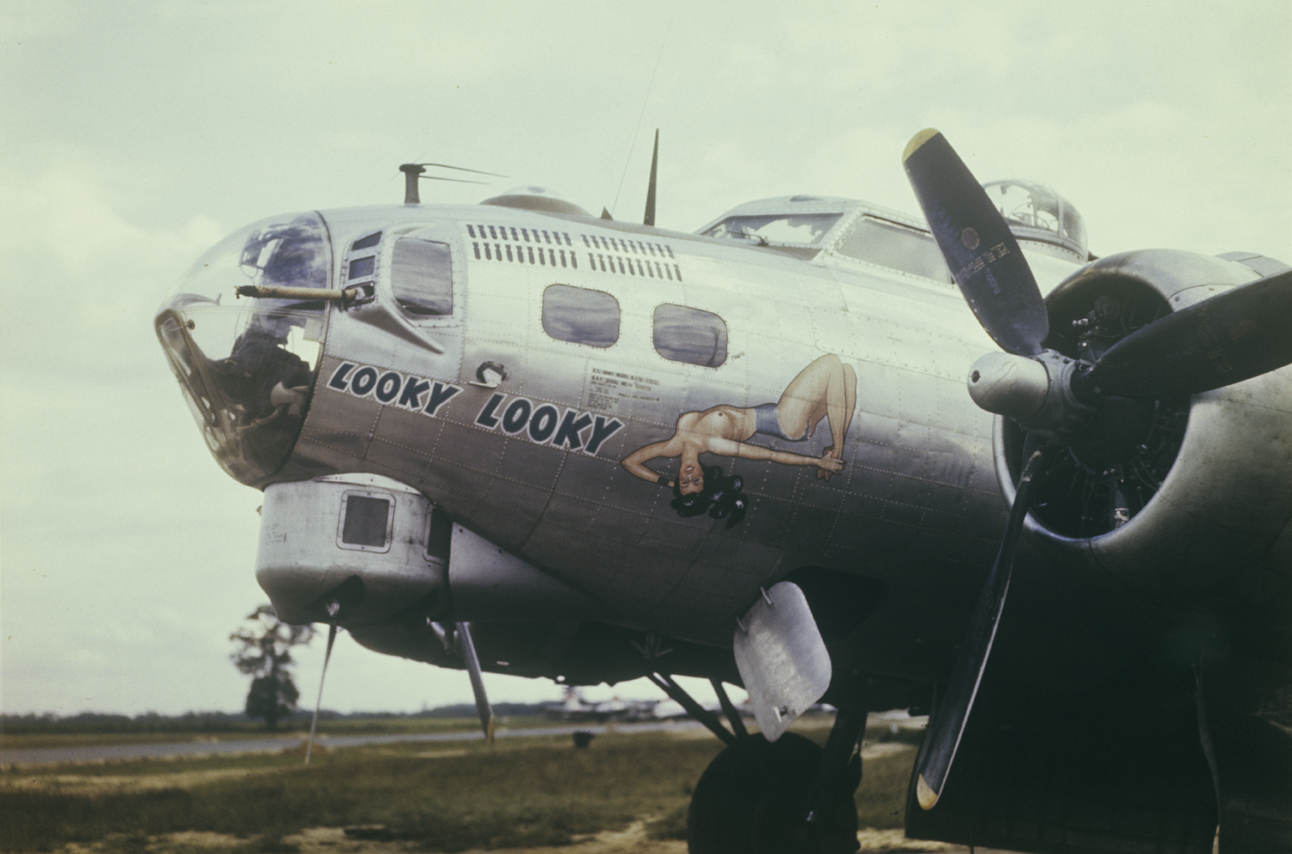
[466,224,682,282]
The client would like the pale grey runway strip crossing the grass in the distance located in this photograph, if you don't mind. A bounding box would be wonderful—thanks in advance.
[0,721,700,766]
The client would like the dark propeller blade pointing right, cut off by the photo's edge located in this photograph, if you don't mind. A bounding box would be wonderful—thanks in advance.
[1080,270,1292,399]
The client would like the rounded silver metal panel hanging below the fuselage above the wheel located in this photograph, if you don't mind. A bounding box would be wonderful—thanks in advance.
[733,581,832,742]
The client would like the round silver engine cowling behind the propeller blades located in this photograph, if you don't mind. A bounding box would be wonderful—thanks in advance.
[994,249,1292,599]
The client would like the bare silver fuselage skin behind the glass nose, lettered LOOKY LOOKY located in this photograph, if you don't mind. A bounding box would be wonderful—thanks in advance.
[288,201,1071,674]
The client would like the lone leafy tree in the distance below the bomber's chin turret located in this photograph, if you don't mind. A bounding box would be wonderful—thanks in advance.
[229,605,314,730]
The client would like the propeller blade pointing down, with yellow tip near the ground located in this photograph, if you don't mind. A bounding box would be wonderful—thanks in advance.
[916,437,1044,810]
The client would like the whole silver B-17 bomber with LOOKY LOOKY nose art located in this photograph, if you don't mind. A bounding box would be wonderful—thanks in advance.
[155,130,1292,854]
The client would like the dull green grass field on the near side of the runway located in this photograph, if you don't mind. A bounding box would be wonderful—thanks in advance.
[0,729,913,854]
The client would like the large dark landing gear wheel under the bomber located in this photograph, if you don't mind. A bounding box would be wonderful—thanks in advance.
[686,733,857,854]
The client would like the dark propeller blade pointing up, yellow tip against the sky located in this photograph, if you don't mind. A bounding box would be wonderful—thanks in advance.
[902,129,1049,355]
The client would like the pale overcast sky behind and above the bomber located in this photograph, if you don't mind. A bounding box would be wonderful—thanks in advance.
[0,0,1292,714]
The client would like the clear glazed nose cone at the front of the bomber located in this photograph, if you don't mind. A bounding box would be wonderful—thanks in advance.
[155,213,332,483]
